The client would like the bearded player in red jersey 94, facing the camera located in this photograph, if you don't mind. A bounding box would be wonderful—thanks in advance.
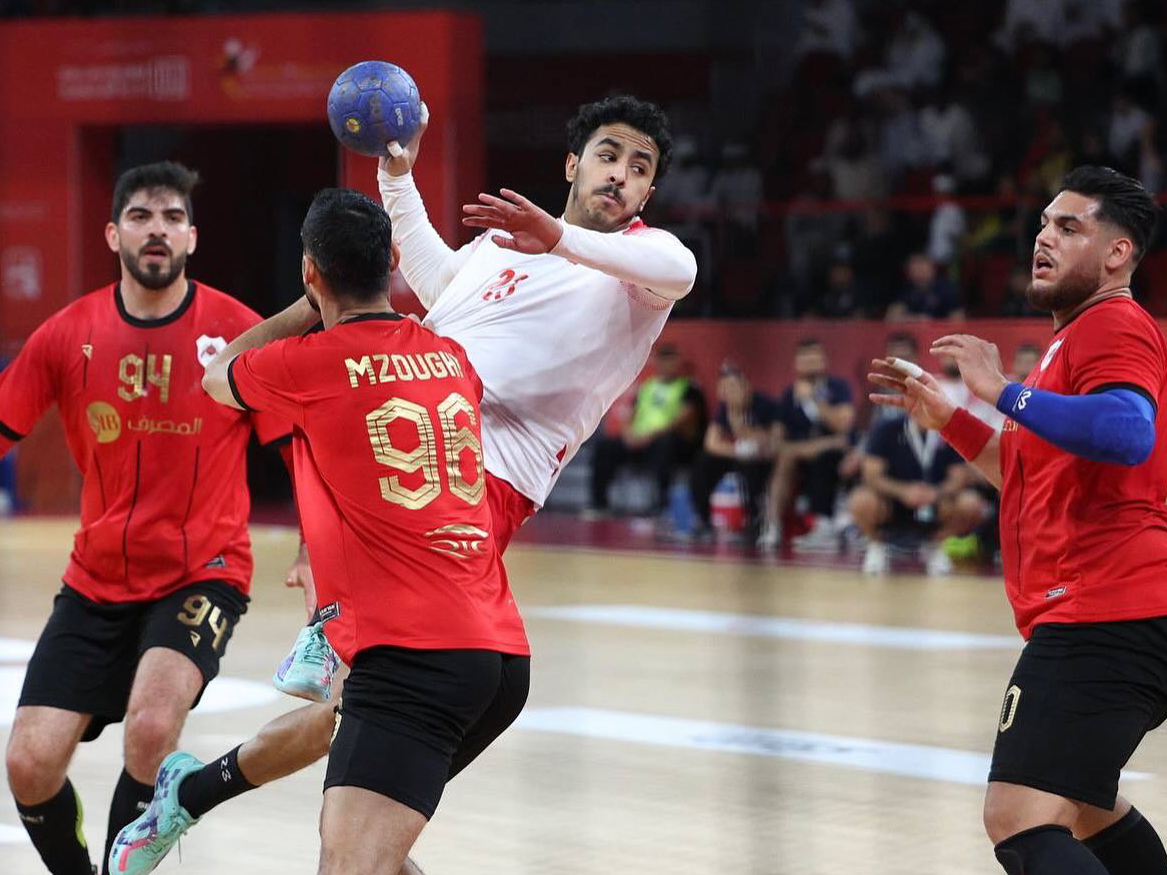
[0,162,296,875]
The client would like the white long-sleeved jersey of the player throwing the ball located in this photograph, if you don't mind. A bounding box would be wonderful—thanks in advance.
[378,173,697,506]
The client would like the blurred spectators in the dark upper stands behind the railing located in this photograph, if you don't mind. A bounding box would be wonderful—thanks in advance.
[657,0,1167,320]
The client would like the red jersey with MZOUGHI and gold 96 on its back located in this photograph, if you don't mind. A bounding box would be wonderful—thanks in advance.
[229,314,530,664]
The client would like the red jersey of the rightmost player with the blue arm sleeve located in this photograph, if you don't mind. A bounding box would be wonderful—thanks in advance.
[1000,298,1167,638]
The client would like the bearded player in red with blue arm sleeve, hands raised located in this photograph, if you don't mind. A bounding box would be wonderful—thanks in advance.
[872,167,1167,875]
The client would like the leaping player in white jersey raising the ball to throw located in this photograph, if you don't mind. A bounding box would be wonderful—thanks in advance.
[111,96,697,875]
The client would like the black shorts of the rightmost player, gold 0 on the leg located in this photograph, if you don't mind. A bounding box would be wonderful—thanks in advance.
[988,617,1167,811]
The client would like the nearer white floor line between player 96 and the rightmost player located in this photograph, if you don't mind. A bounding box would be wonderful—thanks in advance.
[516,708,1153,785]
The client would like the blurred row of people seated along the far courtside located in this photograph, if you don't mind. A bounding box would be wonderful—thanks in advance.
[588,330,1041,575]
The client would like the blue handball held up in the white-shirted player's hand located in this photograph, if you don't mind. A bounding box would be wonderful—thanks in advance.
[328,61,421,158]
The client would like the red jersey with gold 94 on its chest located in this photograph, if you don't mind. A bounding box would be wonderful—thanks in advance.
[0,282,289,603]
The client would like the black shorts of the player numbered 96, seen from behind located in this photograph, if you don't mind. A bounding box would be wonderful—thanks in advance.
[324,645,531,819]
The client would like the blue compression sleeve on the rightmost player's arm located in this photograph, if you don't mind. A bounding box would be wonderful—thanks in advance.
[997,383,1156,466]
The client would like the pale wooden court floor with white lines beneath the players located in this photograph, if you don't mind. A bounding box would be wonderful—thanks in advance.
[0,519,1167,875]
